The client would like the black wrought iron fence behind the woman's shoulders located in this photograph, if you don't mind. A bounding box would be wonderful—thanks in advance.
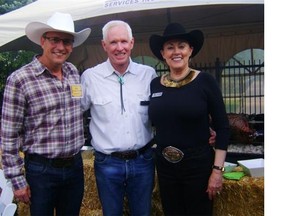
[155,59,264,114]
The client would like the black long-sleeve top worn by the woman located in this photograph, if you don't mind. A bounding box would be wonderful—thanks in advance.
[149,72,229,150]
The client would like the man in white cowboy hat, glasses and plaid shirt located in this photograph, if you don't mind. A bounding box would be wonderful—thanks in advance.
[1,12,91,216]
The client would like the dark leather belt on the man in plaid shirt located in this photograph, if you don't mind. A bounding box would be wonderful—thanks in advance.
[25,152,81,168]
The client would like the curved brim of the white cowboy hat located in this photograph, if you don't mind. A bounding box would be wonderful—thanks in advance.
[25,22,91,47]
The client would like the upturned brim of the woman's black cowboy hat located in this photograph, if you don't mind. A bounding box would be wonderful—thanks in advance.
[149,30,204,61]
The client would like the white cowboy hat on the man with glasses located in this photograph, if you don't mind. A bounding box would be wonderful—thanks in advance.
[25,12,91,47]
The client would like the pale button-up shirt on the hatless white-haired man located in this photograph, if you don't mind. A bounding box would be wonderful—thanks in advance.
[81,59,157,154]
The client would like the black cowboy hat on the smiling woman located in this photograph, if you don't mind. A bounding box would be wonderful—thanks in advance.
[149,23,204,61]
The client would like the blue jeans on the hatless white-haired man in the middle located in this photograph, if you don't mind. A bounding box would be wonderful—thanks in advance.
[94,148,155,216]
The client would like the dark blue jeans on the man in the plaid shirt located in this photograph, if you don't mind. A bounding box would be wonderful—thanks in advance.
[25,154,84,216]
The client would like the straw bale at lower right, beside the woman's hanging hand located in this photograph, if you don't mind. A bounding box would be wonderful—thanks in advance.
[214,176,264,216]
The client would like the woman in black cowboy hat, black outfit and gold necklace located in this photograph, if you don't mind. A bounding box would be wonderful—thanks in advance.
[149,23,229,215]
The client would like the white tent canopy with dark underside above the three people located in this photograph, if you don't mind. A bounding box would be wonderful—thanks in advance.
[0,0,264,68]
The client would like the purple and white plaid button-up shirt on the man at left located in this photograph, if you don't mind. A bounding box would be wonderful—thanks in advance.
[1,58,84,189]
